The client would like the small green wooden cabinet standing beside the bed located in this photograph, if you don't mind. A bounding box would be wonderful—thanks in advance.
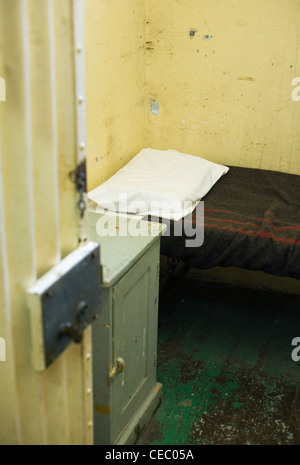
[89,212,162,444]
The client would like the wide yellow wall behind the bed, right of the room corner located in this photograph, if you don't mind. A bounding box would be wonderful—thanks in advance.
[144,0,300,174]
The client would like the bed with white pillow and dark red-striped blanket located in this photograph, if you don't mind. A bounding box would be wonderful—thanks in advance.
[88,148,300,279]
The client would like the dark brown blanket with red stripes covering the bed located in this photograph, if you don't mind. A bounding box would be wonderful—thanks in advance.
[161,167,300,279]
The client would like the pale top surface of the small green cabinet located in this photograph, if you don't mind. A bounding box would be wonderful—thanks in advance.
[88,211,166,286]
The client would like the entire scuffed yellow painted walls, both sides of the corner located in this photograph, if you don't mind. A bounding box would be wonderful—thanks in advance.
[85,0,300,183]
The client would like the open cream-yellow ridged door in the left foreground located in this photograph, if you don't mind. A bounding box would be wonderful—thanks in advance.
[0,0,97,444]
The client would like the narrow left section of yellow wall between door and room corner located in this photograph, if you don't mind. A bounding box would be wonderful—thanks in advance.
[84,0,146,190]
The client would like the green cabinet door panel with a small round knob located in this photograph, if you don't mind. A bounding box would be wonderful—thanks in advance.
[112,241,159,439]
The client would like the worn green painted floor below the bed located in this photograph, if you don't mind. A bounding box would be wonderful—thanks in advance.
[137,280,300,445]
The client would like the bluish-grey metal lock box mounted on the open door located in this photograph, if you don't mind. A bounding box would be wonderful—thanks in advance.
[27,242,102,371]
